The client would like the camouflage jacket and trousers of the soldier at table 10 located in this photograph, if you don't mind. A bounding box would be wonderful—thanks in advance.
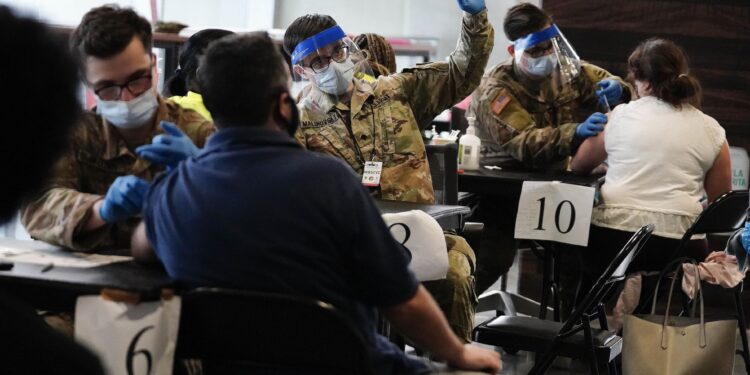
[467,58,634,302]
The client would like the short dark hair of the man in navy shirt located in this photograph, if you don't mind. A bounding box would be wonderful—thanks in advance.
[198,31,290,128]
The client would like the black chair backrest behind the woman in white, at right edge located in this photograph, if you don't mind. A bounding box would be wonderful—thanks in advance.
[670,190,748,259]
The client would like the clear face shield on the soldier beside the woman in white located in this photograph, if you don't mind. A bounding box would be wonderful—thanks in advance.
[513,25,581,85]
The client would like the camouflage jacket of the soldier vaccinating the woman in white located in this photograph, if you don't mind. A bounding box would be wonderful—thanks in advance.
[469,59,634,170]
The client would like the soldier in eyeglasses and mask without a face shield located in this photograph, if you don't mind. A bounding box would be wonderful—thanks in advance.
[21,6,214,251]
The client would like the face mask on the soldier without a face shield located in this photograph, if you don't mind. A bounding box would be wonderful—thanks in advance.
[96,90,159,129]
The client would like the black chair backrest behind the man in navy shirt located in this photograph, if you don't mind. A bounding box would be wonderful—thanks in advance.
[176,288,371,374]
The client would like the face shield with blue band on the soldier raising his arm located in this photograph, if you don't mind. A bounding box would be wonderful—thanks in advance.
[292,26,375,112]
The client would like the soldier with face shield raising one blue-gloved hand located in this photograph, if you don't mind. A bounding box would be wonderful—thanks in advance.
[284,0,494,342]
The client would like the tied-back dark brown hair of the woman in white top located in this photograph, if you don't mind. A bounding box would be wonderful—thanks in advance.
[628,38,702,108]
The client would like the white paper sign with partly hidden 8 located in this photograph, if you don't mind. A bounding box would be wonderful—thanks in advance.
[382,210,448,281]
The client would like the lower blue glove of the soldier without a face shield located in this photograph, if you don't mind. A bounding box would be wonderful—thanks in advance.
[99,175,148,224]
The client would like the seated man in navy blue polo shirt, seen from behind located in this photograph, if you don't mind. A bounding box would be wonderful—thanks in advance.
[133,33,500,374]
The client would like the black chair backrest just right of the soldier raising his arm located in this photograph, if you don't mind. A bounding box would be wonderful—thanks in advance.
[425,143,458,204]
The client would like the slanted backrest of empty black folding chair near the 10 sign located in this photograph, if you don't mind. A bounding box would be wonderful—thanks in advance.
[560,224,654,333]
